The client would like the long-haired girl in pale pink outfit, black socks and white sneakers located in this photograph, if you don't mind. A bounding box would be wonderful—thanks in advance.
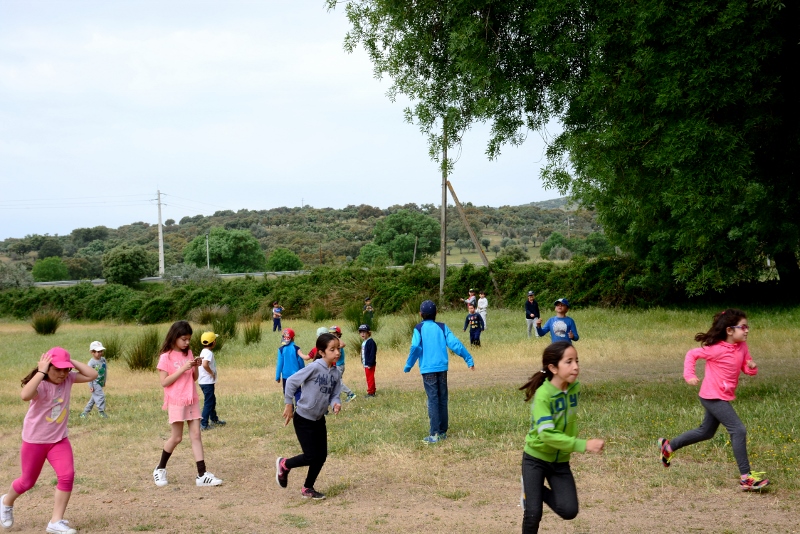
[153,321,222,487]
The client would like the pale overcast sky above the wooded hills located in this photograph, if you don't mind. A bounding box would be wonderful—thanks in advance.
[0,0,559,240]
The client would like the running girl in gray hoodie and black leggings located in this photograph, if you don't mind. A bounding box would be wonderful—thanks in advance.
[275,334,342,500]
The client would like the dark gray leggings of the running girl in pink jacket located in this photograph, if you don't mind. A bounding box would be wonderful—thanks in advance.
[669,397,750,475]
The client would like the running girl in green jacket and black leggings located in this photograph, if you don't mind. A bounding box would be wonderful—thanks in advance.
[519,341,605,534]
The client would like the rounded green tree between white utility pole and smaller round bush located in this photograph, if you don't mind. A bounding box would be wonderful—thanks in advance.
[183,227,267,273]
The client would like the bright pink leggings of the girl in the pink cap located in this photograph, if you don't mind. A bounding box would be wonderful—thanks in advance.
[11,438,75,495]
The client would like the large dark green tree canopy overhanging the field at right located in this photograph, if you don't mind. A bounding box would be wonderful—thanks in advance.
[334,0,800,294]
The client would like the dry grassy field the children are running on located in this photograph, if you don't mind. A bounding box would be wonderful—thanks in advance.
[0,308,800,534]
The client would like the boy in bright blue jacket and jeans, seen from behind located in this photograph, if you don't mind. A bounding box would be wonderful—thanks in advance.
[403,300,475,444]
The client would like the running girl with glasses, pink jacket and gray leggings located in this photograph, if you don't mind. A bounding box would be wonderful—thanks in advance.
[658,308,769,491]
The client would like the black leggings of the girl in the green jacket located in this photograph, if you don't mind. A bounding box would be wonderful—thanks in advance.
[522,452,578,534]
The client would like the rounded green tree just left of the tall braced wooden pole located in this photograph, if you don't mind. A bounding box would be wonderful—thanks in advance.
[373,209,440,265]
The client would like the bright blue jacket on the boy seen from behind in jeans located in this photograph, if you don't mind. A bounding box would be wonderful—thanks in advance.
[403,320,475,375]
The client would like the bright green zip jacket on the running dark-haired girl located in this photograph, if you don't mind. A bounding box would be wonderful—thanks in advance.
[525,380,586,462]
